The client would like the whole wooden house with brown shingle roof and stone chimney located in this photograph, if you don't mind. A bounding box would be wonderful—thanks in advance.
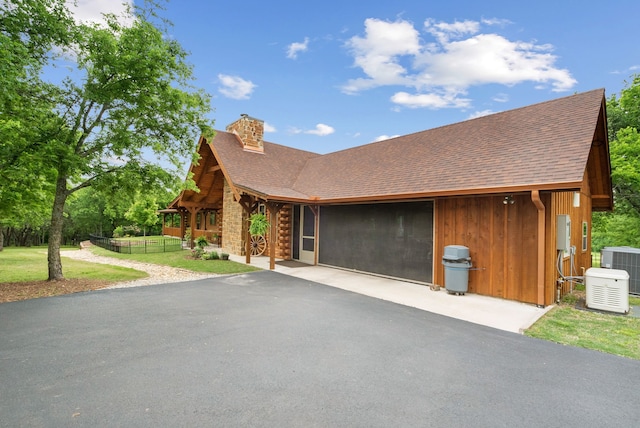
[164,89,613,306]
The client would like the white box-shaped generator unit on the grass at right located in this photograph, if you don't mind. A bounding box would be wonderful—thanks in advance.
[585,268,629,314]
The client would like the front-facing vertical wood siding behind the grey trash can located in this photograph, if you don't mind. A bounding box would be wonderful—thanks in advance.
[434,194,538,303]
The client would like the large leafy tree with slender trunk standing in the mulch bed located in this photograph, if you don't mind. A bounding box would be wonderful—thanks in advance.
[2,0,212,280]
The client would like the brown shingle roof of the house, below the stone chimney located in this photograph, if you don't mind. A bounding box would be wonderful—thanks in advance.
[213,89,604,201]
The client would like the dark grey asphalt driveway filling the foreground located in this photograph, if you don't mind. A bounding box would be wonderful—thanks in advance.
[0,271,640,427]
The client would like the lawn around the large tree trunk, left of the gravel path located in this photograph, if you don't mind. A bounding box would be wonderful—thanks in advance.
[0,247,147,283]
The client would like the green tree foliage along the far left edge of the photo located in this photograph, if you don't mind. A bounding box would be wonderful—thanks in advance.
[0,0,73,250]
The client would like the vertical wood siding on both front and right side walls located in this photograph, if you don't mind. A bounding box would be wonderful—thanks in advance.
[434,177,591,305]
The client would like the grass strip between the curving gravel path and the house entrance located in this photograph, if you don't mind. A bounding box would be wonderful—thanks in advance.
[91,246,260,274]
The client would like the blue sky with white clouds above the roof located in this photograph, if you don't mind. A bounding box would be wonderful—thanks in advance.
[67,0,640,153]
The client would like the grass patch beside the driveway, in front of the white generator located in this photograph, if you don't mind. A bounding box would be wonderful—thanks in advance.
[525,297,640,360]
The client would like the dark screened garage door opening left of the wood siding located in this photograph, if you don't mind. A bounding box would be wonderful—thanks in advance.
[318,201,433,282]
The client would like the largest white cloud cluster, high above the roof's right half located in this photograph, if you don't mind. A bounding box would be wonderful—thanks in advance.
[342,18,577,108]
